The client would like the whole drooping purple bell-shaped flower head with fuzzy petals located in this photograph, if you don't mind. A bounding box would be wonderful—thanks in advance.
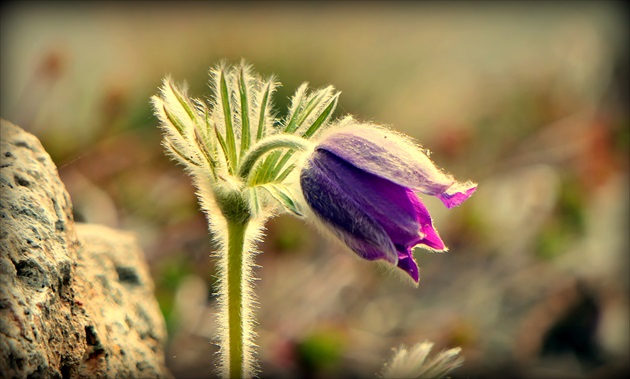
[300,124,477,283]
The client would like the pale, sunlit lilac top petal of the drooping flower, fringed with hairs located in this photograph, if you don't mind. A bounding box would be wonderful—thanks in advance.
[317,124,473,204]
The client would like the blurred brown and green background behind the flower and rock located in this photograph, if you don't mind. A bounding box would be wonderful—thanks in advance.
[0,1,630,378]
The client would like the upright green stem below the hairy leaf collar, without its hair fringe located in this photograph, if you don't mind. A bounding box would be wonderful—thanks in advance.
[227,221,248,378]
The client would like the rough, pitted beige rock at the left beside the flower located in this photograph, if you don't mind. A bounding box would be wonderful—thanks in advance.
[0,120,170,378]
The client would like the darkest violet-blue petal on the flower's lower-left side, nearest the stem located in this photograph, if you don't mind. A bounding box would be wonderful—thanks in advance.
[300,157,398,263]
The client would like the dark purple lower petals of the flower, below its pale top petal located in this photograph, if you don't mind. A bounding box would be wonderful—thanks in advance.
[300,150,446,282]
